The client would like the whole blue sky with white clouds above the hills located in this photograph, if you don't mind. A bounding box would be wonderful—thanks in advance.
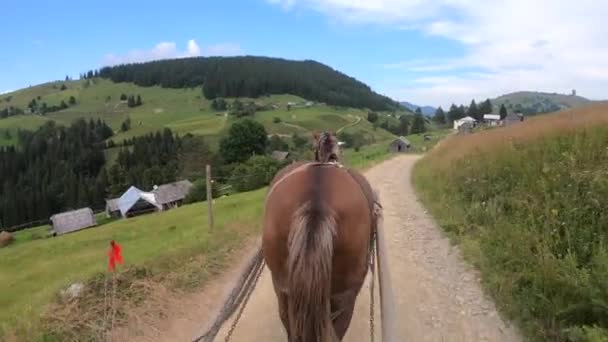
[0,0,608,107]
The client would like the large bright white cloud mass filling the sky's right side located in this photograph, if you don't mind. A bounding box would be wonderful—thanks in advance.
[268,0,608,105]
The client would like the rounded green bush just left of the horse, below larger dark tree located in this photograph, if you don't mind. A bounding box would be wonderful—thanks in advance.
[230,156,281,192]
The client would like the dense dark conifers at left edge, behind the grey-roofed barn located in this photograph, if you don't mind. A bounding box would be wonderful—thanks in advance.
[0,120,112,227]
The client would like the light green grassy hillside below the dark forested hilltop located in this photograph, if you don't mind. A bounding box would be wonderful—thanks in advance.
[0,78,400,146]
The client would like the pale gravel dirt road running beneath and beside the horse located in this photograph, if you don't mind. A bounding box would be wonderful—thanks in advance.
[117,155,521,342]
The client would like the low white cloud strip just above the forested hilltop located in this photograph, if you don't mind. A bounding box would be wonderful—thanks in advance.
[102,39,241,65]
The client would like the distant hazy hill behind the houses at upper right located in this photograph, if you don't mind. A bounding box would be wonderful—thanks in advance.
[492,91,592,115]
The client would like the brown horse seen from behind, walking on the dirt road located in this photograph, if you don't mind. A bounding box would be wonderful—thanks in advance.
[262,133,376,342]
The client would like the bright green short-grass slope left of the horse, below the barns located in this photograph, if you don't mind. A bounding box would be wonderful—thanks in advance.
[0,190,265,336]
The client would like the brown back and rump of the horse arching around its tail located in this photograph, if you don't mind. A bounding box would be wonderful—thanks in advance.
[263,163,373,292]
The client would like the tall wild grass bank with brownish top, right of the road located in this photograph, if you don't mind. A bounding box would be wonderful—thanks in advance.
[413,104,608,341]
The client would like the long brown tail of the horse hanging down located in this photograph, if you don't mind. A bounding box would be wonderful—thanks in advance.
[287,202,337,342]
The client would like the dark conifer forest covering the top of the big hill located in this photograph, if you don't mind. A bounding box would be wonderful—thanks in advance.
[92,56,398,110]
